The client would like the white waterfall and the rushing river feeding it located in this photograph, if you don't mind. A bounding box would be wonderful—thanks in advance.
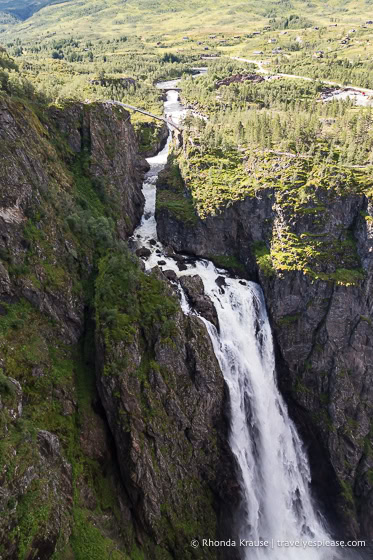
[133,76,354,560]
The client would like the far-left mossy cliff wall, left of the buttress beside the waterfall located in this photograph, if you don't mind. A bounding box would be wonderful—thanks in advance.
[0,98,146,559]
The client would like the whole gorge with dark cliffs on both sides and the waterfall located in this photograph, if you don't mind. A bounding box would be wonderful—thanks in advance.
[0,54,373,560]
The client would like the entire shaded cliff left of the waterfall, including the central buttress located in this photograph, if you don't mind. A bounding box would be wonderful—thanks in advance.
[0,98,234,560]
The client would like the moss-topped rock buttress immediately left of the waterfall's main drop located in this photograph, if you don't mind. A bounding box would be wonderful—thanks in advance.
[96,256,238,558]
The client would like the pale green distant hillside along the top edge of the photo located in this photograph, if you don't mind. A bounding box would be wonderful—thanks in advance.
[0,0,373,40]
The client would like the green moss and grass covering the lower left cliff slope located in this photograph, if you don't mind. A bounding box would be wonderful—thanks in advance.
[0,294,137,560]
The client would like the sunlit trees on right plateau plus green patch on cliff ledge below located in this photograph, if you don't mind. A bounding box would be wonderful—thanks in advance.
[173,60,373,286]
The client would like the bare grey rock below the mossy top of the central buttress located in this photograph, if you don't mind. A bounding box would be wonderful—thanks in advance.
[98,270,235,558]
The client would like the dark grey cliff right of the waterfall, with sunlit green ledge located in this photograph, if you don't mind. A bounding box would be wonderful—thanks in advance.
[157,161,373,538]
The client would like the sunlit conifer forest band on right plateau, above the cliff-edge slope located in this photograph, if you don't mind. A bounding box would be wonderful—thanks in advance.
[182,60,373,166]
